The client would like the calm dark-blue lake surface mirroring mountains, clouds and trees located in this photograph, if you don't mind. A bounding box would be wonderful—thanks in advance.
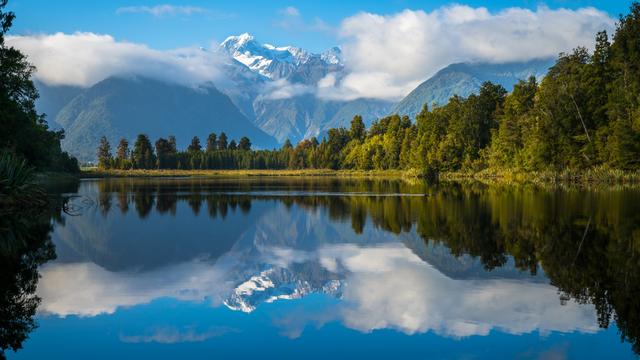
[3,178,640,359]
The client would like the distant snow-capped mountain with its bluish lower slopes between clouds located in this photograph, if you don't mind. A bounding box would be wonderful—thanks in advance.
[216,33,392,143]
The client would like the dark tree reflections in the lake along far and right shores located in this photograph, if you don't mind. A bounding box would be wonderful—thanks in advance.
[99,179,640,353]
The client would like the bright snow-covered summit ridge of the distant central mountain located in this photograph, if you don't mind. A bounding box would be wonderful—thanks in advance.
[219,33,342,80]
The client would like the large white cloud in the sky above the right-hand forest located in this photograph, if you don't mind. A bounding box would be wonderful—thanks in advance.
[320,5,615,99]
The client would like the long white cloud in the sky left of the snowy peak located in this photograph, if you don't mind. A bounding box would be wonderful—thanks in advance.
[6,33,219,86]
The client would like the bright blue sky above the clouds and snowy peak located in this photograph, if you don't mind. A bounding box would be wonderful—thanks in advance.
[9,0,631,51]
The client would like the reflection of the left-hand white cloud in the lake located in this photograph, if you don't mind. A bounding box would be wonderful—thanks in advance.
[38,260,233,317]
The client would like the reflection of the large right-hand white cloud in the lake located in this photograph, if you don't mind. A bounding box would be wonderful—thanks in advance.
[332,246,598,337]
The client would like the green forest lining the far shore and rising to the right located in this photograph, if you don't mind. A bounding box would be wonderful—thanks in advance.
[98,3,640,174]
